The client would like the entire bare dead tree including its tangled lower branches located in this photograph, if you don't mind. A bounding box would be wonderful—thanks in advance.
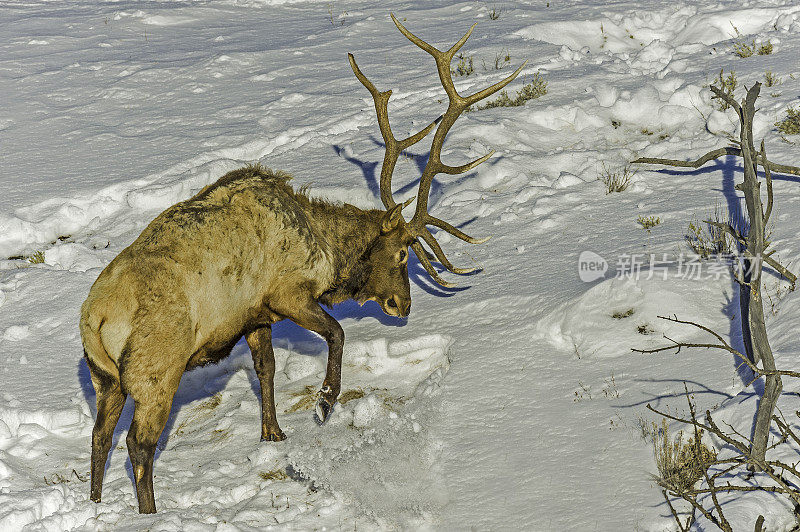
[634,83,800,532]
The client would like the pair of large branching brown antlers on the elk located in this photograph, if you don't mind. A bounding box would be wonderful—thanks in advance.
[347,14,527,287]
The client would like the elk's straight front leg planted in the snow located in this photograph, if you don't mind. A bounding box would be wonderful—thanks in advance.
[245,325,286,441]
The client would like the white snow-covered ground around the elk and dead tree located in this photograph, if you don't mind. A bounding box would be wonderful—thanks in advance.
[0,0,800,531]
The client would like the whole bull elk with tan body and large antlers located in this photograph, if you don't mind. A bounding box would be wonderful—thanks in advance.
[80,15,524,513]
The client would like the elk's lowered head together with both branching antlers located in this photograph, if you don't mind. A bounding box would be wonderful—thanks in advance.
[347,15,527,296]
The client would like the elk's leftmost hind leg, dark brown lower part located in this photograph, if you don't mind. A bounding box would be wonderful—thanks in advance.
[87,359,125,502]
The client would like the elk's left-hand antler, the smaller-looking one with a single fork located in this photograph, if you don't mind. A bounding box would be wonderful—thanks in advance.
[347,53,442,209]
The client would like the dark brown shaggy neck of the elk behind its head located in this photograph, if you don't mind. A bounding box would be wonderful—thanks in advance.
[304,201,385,305]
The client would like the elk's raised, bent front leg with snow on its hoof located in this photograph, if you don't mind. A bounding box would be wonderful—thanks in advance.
[282,300,344,423]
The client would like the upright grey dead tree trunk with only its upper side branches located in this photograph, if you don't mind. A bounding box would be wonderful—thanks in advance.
[633,83,800,460]
